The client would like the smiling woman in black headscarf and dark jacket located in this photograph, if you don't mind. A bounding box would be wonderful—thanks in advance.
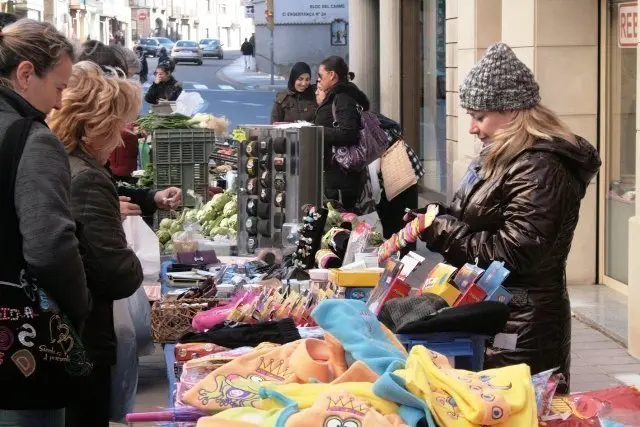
[271,62,317,124]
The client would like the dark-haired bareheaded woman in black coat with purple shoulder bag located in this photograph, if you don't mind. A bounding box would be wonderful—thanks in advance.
[313,56,369,212]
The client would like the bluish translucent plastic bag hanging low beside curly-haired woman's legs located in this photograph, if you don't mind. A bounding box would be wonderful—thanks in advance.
[109,291,139,423]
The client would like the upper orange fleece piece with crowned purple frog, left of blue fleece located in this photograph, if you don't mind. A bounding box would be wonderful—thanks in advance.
[183,339,338,411]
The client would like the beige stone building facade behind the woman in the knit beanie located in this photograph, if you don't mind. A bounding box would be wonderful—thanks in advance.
[349,0,640,357]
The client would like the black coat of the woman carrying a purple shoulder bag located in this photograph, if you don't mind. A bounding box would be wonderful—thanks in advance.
[313,82,369,206]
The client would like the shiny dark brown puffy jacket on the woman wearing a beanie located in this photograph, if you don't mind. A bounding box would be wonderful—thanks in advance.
[422,138,600,393]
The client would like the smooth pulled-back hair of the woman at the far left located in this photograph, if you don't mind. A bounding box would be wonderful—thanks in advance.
[0,19,75,87]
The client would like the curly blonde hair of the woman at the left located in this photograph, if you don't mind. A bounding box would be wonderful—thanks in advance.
[47,61,142,160]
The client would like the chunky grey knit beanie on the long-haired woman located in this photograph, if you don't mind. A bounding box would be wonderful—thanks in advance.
[460,43,540,111]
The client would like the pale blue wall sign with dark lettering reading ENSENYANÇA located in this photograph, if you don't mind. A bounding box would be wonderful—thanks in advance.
[274,0,349,24]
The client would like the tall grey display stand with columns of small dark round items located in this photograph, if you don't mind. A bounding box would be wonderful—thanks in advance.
[238,126,323,254]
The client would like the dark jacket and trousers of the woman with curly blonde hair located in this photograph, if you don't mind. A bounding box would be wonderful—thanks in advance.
[69,148,142,366]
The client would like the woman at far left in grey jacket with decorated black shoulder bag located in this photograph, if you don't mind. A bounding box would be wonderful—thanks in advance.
[0,19,91,427]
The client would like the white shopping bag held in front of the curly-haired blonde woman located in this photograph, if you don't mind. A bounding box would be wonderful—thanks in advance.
[122,216,160,283]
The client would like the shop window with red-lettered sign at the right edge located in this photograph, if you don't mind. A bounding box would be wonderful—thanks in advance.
[604,0,638,284]
